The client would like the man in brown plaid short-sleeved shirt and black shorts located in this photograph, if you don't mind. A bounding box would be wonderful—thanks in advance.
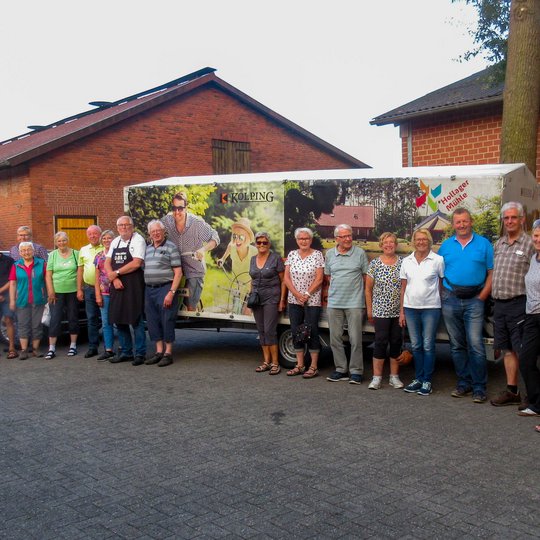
[490,202,535,408]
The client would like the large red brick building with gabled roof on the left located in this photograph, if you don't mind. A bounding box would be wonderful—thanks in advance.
[0,68,367,249]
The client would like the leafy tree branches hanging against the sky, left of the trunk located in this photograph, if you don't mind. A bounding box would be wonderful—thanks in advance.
[451,0,511,69]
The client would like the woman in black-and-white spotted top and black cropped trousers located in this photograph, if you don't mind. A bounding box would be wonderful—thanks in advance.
[366,232,403,390]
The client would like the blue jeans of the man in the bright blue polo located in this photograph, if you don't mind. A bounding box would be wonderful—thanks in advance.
[442,289,487,394]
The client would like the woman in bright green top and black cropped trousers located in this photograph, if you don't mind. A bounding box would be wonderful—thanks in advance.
[45,231,79,360]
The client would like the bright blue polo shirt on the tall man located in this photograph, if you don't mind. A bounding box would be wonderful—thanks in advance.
[438,233,493,289]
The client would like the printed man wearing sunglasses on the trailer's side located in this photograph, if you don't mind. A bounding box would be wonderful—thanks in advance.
[161,191,219,311]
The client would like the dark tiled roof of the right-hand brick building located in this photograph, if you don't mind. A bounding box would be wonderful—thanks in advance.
[370,66,504,126]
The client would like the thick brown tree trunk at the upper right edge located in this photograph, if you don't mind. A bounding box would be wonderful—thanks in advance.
[501,0,540,173]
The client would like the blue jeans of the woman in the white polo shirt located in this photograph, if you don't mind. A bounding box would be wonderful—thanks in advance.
[405,308,441,383]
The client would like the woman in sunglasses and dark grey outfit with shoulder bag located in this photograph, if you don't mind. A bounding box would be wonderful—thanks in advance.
[248,232,286,375]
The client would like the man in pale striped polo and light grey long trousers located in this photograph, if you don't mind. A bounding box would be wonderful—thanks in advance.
[324,225,368,384]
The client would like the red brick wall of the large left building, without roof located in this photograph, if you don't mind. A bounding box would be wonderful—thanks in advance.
[0,87,362,248]
